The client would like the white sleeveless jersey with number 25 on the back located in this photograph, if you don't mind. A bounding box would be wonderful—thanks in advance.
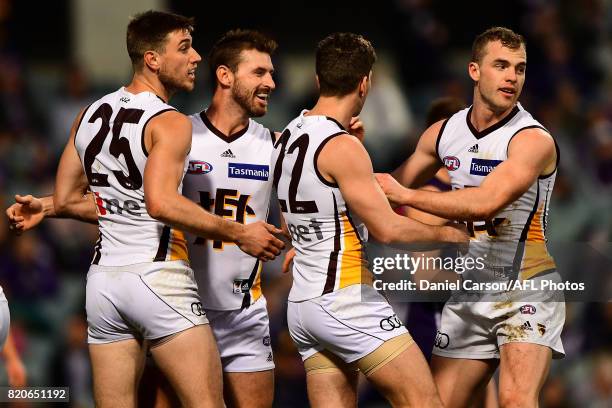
[74,87,187,266]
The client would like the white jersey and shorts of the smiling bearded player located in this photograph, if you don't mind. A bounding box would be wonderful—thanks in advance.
[183,111,274,372]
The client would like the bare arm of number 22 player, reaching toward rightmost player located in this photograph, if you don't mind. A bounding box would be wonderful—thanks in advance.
[317,135,467,243]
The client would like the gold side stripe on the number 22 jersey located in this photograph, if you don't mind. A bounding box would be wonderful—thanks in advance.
[338,212,364,289]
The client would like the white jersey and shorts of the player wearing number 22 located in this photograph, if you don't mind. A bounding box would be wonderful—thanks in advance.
[272,112,406,363]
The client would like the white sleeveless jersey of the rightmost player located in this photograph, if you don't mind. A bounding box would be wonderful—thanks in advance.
[436,104,559,282]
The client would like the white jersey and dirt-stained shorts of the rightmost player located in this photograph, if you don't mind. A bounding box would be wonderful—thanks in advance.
[433,104,565,359]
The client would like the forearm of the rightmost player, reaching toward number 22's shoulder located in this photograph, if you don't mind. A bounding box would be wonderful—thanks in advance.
[400,188,499,221]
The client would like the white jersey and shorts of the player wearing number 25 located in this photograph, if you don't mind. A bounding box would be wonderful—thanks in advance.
[74,87,207,343]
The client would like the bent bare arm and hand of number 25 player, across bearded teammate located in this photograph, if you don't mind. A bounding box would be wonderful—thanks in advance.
[144,111,283,259]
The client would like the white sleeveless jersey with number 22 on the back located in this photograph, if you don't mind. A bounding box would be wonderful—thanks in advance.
[272,111,371,302]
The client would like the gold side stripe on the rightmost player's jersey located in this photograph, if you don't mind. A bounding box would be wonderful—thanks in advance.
[521,203,556,279]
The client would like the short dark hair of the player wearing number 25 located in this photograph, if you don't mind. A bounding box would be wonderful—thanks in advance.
[126,10,195,69]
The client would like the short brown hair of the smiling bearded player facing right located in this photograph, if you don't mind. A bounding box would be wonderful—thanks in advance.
[208,29,278,80]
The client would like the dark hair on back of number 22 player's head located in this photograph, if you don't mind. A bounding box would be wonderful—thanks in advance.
[316,33,376,96]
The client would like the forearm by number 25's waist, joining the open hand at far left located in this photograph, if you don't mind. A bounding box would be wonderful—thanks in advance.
[53,193,98,224]
